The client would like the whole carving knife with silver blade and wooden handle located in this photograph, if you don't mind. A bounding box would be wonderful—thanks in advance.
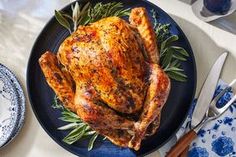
[167,52,228,157]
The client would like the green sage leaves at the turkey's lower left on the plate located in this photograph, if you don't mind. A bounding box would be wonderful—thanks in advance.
[52,96,98,151]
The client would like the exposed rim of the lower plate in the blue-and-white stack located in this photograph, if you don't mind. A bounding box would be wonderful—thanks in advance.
[0,64,26,147]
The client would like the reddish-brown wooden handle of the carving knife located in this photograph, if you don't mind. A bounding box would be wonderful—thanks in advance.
[166,130,197,157]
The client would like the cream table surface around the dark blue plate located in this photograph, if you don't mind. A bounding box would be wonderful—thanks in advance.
[0,0,236,157]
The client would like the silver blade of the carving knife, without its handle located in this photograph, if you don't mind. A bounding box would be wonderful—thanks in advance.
[191,52,228,128]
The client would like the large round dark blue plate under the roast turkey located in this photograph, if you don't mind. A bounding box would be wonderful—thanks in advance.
[27,0,196,157]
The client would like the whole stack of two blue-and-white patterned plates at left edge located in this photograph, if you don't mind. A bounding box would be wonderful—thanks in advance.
[0,64,25,148]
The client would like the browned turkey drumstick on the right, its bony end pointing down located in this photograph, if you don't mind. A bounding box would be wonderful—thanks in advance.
[130,64,170,150]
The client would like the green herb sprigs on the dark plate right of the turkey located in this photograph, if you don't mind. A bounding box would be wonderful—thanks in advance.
[151,10,189,82]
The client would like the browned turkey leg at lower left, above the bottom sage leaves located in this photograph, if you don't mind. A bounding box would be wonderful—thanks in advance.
[75,85,134,130]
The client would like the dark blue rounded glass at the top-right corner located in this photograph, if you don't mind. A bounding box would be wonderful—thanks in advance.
[204,0,231,14]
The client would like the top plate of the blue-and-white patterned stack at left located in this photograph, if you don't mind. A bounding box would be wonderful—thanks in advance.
[0,68,20,147]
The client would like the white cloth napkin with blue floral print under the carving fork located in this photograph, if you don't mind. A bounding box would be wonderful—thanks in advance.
[177,80,236,157]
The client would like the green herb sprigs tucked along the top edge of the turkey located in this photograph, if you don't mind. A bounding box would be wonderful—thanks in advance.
[55,2,130,34]
